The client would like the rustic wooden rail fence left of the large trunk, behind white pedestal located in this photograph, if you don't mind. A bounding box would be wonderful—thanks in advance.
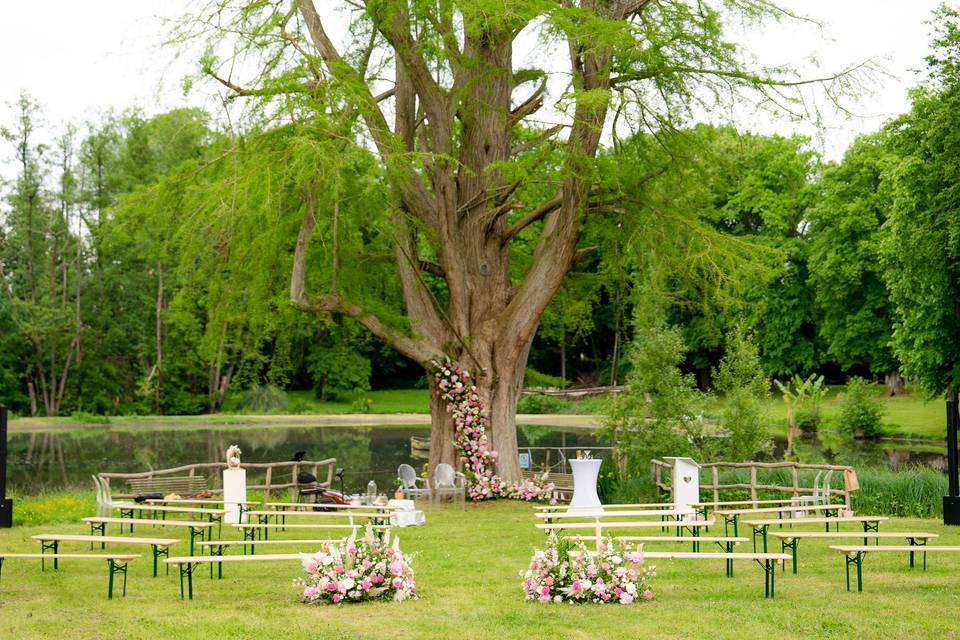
[97,458,337,502]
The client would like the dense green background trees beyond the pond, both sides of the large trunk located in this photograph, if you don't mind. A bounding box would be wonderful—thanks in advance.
[0,8,960,415]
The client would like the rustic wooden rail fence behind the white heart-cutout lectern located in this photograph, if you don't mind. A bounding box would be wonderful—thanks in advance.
[650,460,860,509]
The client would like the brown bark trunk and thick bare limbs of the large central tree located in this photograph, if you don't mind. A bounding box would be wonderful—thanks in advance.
[290,0,628,482]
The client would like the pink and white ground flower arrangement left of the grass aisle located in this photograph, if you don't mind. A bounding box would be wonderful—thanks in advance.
[297,525,419,604]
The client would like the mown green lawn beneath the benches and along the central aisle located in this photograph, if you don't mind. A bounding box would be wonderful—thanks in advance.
[0,496,960,640]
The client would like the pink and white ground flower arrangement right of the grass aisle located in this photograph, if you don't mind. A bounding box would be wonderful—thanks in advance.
[520,533,657,604]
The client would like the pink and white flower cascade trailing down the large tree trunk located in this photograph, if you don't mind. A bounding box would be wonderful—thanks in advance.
[434,360,554,501]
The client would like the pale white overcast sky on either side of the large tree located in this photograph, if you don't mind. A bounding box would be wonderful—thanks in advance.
[0,0,939,172]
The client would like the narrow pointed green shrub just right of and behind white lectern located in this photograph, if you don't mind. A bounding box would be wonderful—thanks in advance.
[714,329,773,462]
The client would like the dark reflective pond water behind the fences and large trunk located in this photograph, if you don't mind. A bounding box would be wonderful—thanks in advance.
[7,425,946,495]
